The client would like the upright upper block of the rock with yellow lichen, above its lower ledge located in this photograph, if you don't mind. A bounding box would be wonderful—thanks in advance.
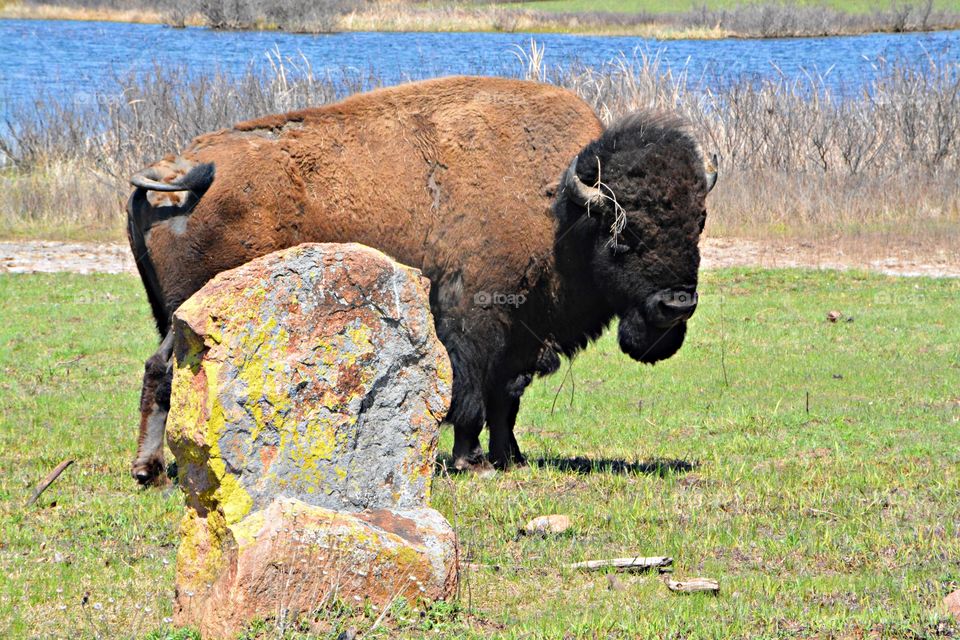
[168,245,451,523]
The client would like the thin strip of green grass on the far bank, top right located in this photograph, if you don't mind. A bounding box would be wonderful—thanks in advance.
[501,0,960,14]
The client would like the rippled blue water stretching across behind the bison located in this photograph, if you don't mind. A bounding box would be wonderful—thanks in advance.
[0,20,960,117]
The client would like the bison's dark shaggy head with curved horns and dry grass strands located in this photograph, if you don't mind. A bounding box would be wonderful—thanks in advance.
[563,113,717,363]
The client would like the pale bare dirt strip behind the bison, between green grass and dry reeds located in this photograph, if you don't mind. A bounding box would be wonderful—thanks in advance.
[0,238,960,278]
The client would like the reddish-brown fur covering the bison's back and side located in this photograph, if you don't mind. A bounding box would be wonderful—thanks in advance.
[147,78,601,322]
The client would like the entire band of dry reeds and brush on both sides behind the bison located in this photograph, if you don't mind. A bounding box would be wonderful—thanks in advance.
[0,50,960,253]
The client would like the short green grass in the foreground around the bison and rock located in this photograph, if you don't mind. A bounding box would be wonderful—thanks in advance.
[0,270,960,639]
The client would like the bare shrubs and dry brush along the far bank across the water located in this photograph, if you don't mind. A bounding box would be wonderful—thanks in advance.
[15,0,960,38]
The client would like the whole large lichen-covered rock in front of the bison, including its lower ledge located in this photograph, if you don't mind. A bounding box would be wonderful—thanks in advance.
[167,244,457,637]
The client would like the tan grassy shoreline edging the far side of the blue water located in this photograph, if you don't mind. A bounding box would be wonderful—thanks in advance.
[7,4,960,40]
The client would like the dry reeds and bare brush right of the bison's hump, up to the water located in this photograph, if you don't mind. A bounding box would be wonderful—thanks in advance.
[548,49,960,251]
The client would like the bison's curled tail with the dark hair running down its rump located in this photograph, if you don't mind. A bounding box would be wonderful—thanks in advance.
[127,162,215,338]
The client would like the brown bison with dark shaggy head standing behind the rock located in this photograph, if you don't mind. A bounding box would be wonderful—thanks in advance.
[128,77,716,484]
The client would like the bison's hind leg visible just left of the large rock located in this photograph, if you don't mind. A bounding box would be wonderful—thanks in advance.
[131,331,173,485]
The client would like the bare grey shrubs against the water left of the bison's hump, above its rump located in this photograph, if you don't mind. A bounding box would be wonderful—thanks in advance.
[0,52,381,180]
